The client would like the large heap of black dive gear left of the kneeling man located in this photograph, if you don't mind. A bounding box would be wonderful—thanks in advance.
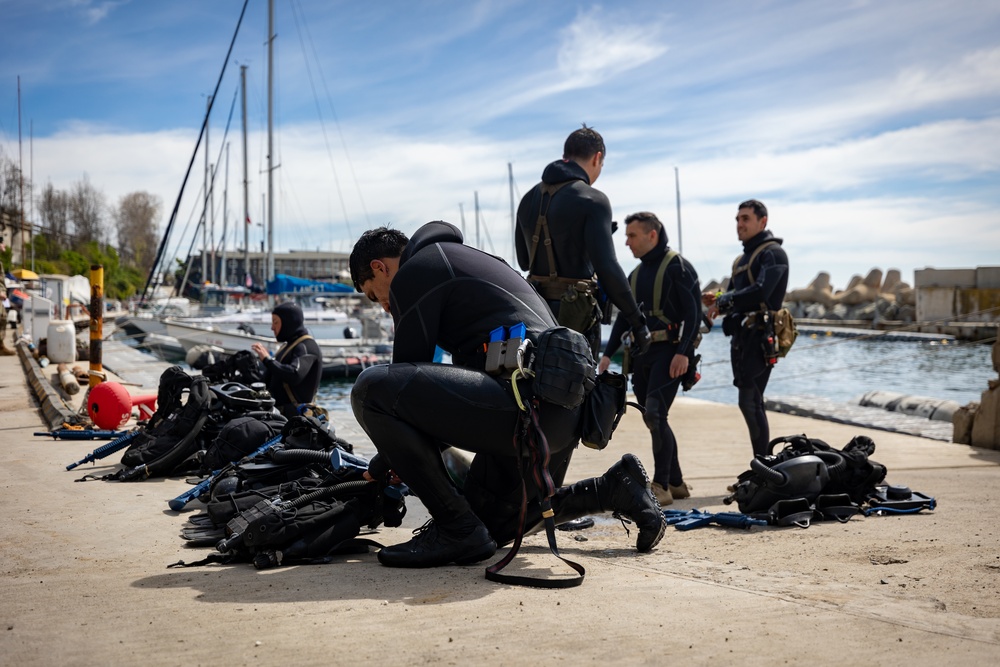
[67,353,407,569]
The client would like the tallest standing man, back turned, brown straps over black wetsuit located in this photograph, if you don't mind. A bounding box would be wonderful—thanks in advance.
[515,125,649,359]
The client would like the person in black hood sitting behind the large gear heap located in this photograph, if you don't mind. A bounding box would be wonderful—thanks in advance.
[252,303,323,417]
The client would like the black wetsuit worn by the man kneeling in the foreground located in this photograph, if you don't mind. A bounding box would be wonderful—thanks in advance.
[351,222,584,543]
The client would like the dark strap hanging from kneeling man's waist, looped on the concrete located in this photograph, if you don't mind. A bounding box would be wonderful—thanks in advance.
[486,399,587,588]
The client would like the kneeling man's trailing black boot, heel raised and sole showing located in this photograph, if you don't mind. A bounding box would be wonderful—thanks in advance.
[597,454,667,552]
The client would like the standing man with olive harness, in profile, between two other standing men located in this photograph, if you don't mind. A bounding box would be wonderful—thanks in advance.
[598,211,701,505]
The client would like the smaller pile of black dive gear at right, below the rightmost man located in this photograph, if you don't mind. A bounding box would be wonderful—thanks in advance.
[724,435,936,529]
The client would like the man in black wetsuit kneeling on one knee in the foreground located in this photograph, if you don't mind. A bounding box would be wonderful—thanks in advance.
[350,222,666,567]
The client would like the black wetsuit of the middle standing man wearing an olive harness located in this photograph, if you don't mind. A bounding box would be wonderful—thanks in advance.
[604,234,701,488]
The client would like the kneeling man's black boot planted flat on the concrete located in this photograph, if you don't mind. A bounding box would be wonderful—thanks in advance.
[378,512,497,567]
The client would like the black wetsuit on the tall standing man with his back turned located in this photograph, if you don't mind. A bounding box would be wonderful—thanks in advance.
[515,160,638,357]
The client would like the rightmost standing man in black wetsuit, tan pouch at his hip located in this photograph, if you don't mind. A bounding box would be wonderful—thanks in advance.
[702,199,788,456]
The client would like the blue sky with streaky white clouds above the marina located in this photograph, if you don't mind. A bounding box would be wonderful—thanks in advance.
[0,0,1000,289]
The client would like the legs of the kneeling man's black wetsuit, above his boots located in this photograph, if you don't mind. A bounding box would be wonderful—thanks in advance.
[351,363,580,527]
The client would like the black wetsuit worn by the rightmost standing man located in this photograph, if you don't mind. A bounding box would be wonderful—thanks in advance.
[722,230,788,455]
